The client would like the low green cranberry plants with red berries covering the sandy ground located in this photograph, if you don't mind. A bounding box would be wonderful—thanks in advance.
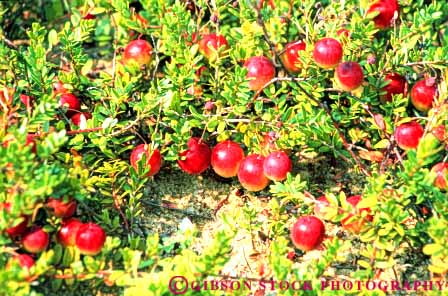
[0,0,448,295]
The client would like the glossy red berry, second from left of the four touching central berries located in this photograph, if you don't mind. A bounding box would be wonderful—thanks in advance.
[211,140,244,178]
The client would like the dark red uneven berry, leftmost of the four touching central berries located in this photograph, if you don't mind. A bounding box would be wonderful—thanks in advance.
[177,137,211,175]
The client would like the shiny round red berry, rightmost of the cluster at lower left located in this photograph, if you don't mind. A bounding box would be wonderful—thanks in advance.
[75,222,106,256]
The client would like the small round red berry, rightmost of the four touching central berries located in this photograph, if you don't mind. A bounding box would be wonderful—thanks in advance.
[263,151,292,181]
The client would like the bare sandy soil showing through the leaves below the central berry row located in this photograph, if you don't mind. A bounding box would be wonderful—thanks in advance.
[139,157,428,290]
